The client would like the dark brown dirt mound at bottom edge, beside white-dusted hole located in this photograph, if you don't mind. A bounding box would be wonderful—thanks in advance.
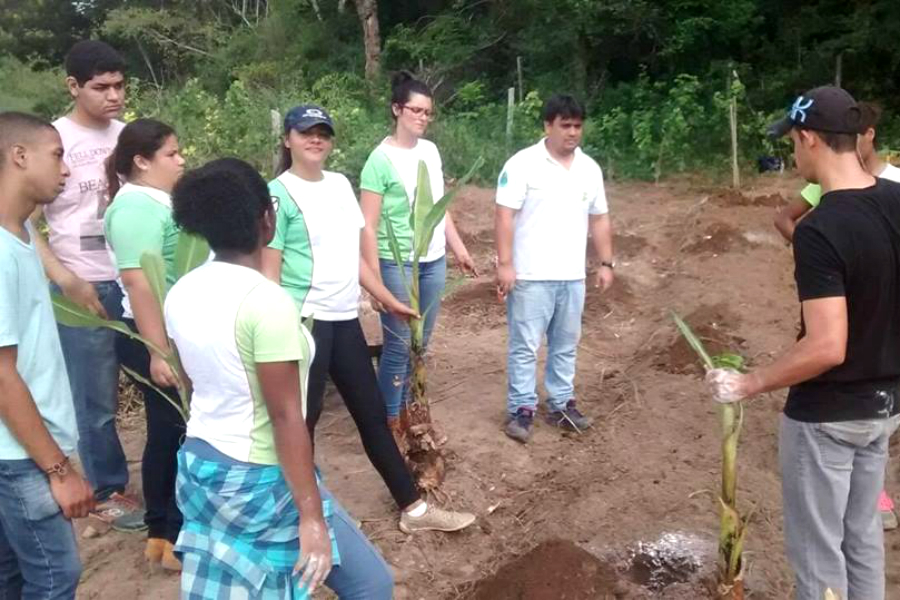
[469,539,630,600]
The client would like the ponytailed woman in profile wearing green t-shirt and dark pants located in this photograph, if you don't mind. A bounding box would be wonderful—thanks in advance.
[104,119,185,570]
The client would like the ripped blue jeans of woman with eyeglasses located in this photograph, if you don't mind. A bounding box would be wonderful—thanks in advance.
[378,257,447,417]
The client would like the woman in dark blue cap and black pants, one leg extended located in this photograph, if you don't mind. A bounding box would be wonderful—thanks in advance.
[263,105,475,533]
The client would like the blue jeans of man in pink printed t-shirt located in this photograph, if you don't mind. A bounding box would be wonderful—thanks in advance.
[53,281,128,500]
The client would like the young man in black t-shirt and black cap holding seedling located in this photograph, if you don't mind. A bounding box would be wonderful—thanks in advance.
[707,86,900,600]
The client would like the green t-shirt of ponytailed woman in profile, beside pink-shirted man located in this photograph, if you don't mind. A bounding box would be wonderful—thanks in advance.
[104,183,179,286]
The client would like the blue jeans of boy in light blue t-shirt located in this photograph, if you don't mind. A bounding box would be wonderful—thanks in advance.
[0,459,81,600]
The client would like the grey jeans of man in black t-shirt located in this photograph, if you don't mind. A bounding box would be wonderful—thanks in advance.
[779,415,900,600]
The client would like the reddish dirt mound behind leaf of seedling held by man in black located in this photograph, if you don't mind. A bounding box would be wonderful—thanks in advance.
[651,304,746,375]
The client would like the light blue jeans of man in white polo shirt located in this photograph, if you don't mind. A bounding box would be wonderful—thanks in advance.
[506,279,584,414]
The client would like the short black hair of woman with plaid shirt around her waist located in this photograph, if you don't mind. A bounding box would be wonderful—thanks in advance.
[172,158,272,254]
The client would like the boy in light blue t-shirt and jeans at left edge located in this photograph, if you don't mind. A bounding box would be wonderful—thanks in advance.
[0,112,94,600]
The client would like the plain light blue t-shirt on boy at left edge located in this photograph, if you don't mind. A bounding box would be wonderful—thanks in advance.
[0,224,78,460]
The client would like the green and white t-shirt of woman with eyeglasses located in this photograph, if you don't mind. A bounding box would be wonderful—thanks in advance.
[359,139,447,262]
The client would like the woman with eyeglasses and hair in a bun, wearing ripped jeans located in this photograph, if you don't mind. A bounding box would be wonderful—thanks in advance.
[360,72,476,435]
